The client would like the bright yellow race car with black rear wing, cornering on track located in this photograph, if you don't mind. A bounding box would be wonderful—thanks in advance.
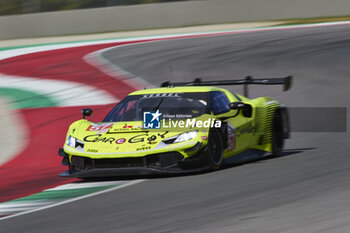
[59,76,292,179]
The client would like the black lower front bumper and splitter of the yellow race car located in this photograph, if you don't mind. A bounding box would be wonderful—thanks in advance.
[59,147,209,179]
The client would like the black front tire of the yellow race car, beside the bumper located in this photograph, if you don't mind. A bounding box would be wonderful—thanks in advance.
[206,129,224,170]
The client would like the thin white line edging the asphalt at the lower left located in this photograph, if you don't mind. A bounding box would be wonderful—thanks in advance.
[0,180,145,221]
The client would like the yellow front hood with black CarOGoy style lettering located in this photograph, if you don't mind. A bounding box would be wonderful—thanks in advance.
[65,118,213,156]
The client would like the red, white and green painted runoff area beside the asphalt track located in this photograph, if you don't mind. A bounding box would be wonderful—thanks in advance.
[0,21,350,220]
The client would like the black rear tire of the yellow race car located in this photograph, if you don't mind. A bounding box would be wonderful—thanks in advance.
[271,110,284,157]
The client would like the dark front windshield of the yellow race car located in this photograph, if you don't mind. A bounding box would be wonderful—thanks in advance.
[103,92,209,122]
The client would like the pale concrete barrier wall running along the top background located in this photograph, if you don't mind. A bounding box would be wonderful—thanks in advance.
[0,0,350,39]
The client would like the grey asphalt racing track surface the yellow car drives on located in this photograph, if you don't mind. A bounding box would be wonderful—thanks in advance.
[0,26,350,233]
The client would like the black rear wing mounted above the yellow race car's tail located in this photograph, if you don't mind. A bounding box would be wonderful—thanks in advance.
[161,76,293,97]
